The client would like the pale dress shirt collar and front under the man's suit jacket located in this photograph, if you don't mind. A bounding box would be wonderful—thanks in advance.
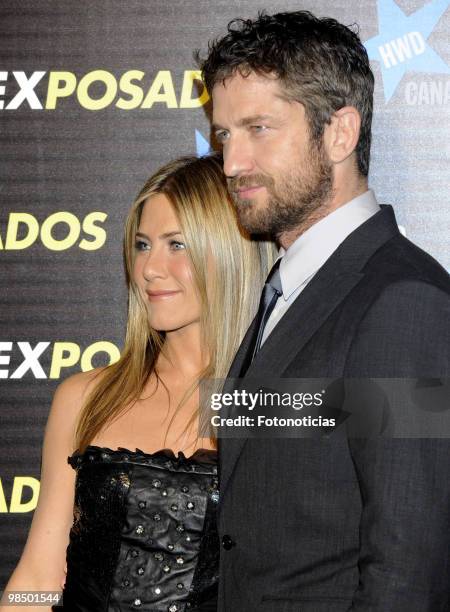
[261,190,380,345]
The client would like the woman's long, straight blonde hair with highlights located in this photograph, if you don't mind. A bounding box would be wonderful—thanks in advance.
[75,154,275,452]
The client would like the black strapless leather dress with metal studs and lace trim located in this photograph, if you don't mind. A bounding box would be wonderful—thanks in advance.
[59,446,219,612]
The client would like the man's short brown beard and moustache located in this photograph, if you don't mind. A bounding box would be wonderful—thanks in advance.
[228,143,333,238]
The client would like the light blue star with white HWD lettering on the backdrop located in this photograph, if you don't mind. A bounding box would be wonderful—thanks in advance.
[364,0,450,102]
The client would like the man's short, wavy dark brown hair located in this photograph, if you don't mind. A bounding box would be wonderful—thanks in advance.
[197,11,374,176]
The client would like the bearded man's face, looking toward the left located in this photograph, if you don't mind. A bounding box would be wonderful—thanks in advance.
[212,72,332,237]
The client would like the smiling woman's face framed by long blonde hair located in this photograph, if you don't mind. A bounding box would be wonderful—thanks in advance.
[133,194,201,332]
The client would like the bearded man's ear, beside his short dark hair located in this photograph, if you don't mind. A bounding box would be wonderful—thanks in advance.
[324,106,361,164]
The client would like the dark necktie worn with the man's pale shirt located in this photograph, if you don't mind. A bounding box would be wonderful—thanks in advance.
[240,258,282,377]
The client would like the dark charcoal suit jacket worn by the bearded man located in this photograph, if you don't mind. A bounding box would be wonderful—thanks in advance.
[219,206,450,612]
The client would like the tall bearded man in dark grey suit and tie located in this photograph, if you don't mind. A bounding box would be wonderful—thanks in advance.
[202,12,450,612]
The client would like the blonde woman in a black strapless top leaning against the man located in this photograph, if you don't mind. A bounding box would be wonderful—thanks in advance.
[2,156,272,612]
